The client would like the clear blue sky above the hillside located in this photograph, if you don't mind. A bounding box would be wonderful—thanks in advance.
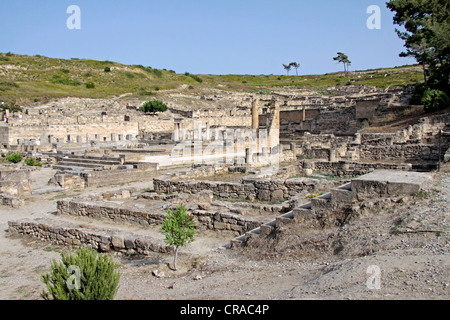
[0,0,415,74]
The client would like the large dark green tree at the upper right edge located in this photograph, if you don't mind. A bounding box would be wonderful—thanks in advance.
[386,0,450,94]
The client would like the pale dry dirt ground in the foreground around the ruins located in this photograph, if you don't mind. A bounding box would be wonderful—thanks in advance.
[0,170,450,300]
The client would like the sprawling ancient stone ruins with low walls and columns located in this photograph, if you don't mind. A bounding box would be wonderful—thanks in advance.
[0,82,450,262]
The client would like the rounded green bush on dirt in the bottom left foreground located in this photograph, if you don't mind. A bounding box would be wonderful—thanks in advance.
[41,248,120,300]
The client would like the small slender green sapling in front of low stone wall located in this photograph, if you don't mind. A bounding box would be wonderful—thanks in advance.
[161,206,196,270]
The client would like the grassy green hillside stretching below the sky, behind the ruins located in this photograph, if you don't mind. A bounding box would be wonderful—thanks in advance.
[0,53,423,104]
